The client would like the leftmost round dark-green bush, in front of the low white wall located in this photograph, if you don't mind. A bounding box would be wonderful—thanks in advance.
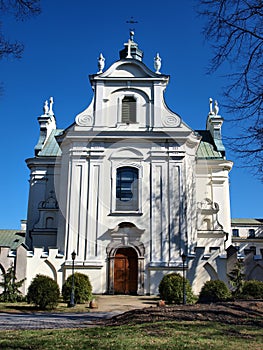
[27,275,60,310]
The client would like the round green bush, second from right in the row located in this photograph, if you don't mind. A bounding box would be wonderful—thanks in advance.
[198,280,231,303]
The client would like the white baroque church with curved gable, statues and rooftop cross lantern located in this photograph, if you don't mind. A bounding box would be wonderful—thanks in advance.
[0,31,261,295]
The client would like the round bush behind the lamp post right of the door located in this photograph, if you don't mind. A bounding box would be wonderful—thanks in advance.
[159,273,195,304]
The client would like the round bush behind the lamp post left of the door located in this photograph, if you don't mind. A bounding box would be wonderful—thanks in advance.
[62,272,92,304]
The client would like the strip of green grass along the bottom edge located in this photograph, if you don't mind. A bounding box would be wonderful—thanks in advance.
[0,321,263,350]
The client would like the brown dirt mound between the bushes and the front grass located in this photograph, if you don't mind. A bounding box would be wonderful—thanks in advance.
[105,301,263,327]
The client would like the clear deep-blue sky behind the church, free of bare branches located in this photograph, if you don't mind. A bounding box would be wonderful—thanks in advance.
[0,0,263,228]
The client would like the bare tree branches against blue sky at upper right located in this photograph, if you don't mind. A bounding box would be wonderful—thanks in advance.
[198,0,263,180]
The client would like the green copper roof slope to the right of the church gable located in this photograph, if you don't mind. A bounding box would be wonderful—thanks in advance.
[197,130,224,159]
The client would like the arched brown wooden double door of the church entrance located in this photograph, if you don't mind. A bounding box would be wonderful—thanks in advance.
[114,248,138,294]
